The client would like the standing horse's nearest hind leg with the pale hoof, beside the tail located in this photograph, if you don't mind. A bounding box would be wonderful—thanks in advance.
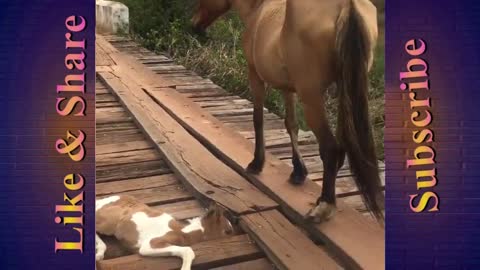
[304,94,344,222]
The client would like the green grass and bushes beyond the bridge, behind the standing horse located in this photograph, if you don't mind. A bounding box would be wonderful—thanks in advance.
[120,0,384,159]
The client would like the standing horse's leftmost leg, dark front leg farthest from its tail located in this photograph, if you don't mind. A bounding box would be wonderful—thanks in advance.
[247,67,266,173]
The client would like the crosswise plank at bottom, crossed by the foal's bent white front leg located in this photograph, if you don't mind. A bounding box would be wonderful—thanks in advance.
[97,235,262,270]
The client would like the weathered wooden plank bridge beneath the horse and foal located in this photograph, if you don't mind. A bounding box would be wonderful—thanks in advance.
[96,35,385,270]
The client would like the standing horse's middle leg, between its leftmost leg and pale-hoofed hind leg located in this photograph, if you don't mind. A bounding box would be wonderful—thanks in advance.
[283,90,308,185]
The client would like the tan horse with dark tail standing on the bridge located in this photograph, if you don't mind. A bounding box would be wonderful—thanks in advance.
[192,0,384,222]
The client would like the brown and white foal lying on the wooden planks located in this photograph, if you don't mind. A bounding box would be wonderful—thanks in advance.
[95,195,233,270]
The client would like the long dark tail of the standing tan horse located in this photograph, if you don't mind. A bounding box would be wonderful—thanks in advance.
[336,0,384,221]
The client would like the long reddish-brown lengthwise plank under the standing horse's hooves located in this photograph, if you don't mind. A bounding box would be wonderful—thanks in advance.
[107,54,385,270]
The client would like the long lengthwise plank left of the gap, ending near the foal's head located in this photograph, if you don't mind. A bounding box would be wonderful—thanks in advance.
[97,69,277,213]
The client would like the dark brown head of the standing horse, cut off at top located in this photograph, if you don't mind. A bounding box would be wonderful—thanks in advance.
[192,0,231,32]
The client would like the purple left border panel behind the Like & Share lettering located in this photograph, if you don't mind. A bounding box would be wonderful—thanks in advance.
[0,0,95,270]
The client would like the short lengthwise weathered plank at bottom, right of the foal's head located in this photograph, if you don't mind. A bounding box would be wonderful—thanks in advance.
[240,210,339,270]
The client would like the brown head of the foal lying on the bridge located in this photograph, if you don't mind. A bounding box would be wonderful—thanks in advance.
[202,203,234,240]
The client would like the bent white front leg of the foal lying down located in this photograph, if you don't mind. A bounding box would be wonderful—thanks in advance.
[138,239,195,270]
